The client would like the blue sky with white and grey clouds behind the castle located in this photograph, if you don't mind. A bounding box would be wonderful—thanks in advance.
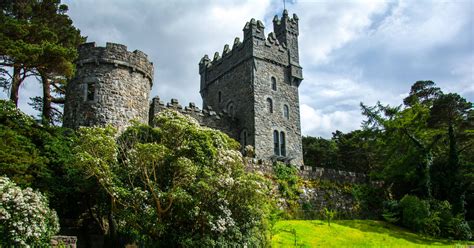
[1,0,474,138]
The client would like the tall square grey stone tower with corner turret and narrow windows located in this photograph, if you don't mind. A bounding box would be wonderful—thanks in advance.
[199,10,303,165]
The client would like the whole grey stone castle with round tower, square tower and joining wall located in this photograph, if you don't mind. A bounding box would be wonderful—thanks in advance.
[64,10,303,165]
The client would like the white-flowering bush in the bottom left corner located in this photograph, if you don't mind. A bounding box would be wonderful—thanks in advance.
[0,176,59,247]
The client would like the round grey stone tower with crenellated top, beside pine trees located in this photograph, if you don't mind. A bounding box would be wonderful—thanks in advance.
[63,42,153,129]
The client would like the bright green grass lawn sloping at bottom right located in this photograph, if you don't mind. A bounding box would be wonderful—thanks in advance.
[272,220,474,248]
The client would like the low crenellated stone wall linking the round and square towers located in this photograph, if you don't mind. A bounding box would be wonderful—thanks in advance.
[149,96,238,138]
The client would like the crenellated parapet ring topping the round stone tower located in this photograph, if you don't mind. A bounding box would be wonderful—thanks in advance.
[76,42,153,84]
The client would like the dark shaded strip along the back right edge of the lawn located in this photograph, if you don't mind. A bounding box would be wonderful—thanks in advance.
[334,220,466,245]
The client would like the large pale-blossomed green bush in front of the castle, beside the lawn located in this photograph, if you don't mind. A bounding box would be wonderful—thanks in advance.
[76,111,270,247]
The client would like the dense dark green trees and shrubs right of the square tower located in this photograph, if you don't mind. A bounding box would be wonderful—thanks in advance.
[303,81,474,239]
